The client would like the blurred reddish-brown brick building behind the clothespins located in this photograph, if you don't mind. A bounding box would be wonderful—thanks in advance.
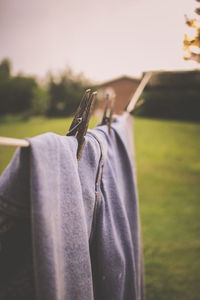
[95,76,140,115]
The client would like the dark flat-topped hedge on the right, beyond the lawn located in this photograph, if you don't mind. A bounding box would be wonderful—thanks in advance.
[139,70,200,122]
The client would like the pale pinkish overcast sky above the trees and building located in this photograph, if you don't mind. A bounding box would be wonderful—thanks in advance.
[0,0,197,81]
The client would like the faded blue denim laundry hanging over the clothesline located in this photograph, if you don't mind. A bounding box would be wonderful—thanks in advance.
[0,114,144,300]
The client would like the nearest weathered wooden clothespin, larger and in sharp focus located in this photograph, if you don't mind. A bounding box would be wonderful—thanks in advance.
[66,89,97,160]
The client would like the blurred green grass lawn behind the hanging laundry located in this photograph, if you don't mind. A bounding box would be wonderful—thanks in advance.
[0,118,200,300]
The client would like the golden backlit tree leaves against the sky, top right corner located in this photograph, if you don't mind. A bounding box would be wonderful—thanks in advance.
[183,0,200,63]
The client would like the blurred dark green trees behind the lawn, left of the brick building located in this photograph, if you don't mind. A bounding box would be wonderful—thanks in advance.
[0,59,92,117]
